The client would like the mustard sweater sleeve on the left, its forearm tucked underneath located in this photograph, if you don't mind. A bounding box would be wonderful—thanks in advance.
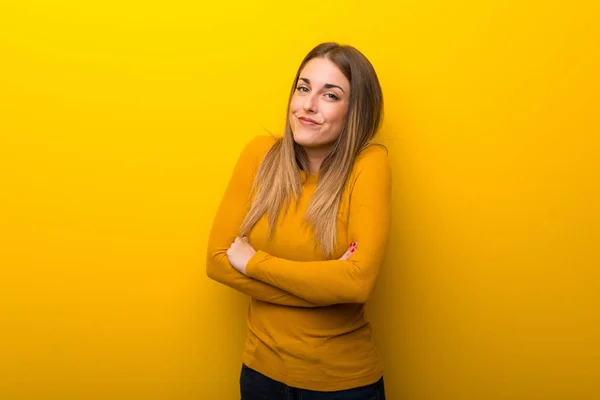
[206,136,318,307]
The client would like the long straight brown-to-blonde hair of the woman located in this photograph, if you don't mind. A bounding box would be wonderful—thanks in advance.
[239,42,383,258]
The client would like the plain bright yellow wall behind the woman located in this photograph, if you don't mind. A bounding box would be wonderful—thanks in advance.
[0,0,600,400]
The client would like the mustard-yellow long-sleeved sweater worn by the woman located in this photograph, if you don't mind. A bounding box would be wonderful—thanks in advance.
[206,136,391,391]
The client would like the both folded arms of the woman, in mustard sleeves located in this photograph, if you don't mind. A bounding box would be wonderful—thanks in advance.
[206,137,391,307]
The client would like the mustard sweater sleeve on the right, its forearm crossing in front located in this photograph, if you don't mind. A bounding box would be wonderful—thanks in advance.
[246,147,391,305]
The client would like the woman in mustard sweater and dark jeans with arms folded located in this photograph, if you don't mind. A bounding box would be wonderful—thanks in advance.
[206,43,391,400]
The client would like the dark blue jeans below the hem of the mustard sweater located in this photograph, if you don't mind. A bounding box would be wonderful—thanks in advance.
[240,364,385,400]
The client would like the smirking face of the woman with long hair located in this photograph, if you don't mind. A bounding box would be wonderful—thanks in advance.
[289,57,350,149]
